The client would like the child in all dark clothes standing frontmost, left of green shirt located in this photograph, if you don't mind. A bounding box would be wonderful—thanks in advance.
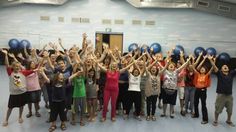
[41,70,67,132]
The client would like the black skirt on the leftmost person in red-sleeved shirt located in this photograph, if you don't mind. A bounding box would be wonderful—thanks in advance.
[8,92,28,109]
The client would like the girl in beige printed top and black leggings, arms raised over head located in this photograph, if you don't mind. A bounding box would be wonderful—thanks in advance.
[145,60,167,121]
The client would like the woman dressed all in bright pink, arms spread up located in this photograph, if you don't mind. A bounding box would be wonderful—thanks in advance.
[97,62,133,122]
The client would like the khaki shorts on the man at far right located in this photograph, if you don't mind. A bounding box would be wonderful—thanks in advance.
[215,94,233,114]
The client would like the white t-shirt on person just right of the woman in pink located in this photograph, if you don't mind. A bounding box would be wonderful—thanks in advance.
[128,74,141,92]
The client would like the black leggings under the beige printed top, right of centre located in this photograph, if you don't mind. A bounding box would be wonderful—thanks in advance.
[146,95,158,116]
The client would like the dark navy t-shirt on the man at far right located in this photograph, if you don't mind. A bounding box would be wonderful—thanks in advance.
[216,70,236,95]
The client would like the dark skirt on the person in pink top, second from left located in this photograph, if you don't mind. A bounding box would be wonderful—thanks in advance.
[27,90,41,103]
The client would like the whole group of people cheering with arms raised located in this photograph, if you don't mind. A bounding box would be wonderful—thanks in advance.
[1,34,236,131]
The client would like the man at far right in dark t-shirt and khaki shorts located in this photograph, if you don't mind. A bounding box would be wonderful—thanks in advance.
[208,56,236,127]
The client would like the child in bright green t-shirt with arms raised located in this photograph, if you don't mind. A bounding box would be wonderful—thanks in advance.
[69,65,86,126]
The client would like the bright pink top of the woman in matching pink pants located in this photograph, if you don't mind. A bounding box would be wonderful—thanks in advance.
[105,71,120,91]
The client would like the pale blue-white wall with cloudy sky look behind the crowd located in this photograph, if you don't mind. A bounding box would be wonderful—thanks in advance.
[0,0,236,56]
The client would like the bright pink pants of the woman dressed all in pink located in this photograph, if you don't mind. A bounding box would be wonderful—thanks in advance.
[102,90,119,118]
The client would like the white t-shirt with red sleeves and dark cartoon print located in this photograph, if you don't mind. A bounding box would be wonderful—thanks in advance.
[7,67,33,95]
